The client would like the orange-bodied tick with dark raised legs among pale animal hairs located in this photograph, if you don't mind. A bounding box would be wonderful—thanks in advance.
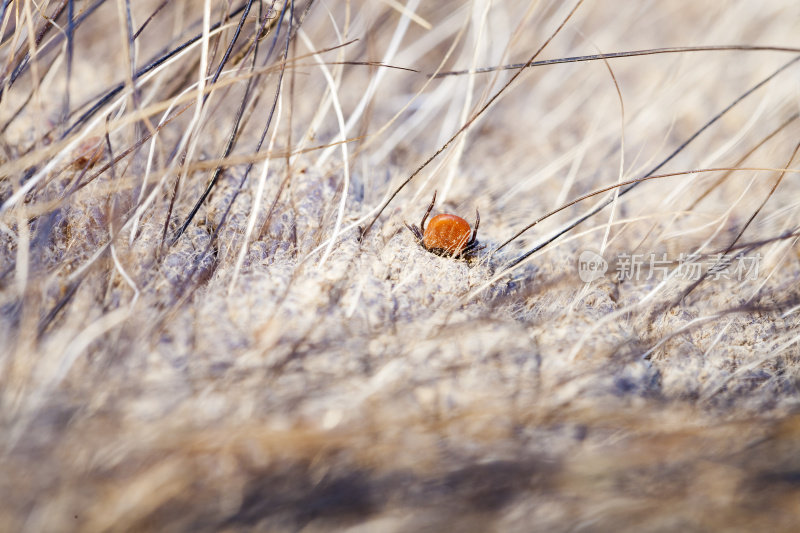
[404,191,482,259]
